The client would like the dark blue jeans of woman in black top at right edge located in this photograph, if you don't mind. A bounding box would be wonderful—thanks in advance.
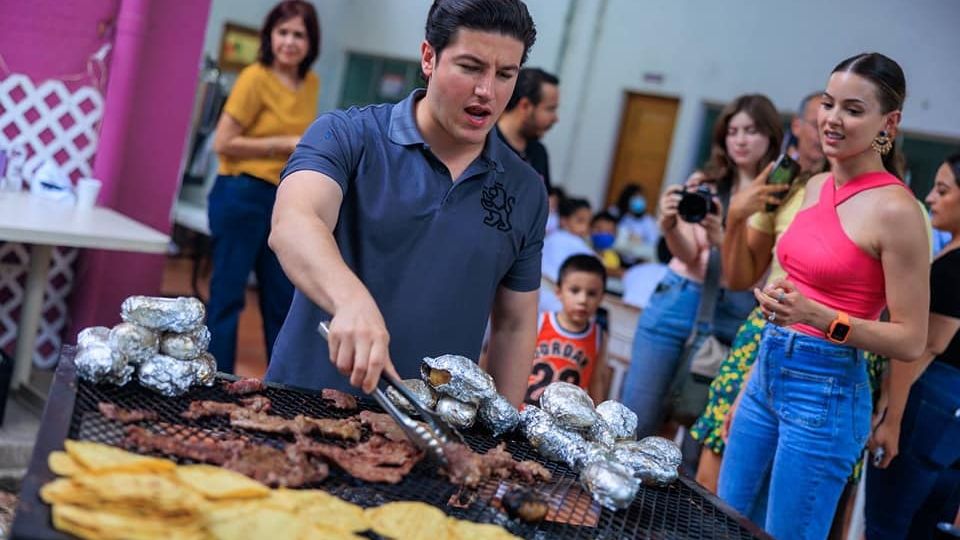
[865,361,960,540]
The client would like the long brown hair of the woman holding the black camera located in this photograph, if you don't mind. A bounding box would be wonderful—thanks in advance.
[703,94,783,192]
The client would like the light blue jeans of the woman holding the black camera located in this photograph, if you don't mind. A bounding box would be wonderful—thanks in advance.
[621,270,755,437]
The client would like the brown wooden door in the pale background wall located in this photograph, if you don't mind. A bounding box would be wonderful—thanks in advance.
[607,92,680,213]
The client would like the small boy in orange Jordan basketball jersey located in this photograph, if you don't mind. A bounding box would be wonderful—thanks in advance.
[524,255,607,405]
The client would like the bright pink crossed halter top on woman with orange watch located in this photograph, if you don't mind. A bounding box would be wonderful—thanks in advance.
[777,172,906,338]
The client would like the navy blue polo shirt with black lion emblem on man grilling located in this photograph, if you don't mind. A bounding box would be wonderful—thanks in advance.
[266,90,547,391]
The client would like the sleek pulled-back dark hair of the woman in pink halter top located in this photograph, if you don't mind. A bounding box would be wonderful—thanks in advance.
[831,53,907,180]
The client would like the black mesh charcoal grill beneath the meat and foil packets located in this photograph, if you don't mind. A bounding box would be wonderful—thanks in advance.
[12,347,769,540]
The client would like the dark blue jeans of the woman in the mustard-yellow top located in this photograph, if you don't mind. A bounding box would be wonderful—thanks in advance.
[207,175,293,373]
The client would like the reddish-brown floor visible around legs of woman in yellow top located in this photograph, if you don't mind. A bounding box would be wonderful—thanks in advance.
[162,257,267,377]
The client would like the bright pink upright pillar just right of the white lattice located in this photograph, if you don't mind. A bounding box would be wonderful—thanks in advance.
[67,0,210,335]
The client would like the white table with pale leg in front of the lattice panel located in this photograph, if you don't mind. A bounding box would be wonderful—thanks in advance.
[0,192,170,388]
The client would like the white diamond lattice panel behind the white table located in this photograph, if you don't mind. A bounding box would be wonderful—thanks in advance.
[0,73,103,366]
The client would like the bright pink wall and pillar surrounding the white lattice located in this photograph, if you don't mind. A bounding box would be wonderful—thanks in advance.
[0,0,210,341]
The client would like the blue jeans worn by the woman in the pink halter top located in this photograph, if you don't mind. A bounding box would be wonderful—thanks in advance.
[718,325,873,540]
